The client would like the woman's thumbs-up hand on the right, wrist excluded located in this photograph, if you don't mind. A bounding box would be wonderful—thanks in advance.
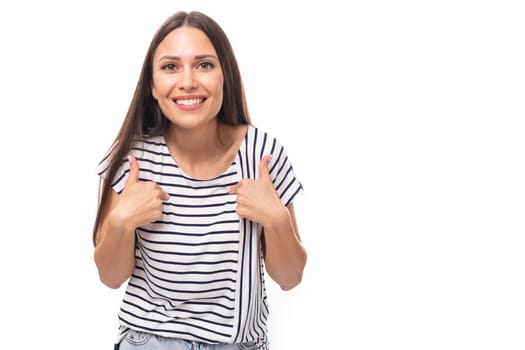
[229,154,284,226]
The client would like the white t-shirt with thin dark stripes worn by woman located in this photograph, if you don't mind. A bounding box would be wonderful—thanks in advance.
[97,126,303,348]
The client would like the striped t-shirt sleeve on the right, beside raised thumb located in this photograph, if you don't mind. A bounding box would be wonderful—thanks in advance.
[269,141,304,205]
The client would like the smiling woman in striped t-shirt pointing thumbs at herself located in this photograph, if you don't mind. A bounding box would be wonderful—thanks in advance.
[93,12,306,350]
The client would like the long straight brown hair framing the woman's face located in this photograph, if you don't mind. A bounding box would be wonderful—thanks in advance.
[93,11,251,245]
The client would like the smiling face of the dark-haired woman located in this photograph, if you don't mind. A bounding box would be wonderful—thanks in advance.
[152,26,224,128]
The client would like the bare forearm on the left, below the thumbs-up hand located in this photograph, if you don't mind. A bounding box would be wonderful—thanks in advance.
[94,219,135,288]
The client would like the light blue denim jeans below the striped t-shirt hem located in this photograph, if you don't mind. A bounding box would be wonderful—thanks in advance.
[115,330,257,350]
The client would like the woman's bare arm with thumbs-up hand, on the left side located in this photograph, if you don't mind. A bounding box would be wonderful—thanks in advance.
[94,157,168,289]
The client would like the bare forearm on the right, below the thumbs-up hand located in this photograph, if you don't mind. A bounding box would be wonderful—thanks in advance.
[264,208,307,290]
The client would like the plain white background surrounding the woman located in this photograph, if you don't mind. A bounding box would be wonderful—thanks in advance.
[0,0,525,350]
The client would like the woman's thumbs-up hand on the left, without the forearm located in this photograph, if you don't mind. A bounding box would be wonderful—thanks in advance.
[115,156,169,229]
